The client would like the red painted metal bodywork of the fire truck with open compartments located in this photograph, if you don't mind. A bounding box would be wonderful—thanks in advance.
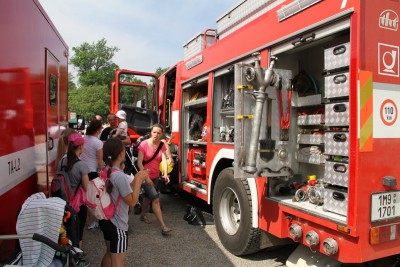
[160,0,400,262]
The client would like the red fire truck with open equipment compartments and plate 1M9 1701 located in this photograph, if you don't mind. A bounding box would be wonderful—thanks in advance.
[115,0,400,266]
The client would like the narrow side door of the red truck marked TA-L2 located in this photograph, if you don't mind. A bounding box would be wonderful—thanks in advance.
[45,50,60,193]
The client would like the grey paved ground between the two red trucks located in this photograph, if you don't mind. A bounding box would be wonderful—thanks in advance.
[84,193,294,267]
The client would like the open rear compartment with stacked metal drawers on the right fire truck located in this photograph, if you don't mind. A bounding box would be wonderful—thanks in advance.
[267,23,350,224]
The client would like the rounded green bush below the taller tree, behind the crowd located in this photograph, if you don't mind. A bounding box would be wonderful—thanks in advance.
[68,85,110,122]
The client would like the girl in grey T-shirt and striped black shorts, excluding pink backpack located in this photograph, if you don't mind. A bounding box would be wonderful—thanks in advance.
[99,138,149,267]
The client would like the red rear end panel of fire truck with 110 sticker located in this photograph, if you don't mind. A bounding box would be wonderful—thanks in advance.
[349,1,400,259]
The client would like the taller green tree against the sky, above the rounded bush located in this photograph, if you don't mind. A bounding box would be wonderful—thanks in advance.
[70,38,119,87]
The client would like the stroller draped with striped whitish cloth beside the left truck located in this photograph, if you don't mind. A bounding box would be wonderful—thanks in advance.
[0,193,82,267]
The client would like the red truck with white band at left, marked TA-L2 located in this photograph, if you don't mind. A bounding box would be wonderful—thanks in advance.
[0,0,68,261]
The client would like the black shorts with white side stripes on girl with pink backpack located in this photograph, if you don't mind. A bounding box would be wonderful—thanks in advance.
[99,220,128,253]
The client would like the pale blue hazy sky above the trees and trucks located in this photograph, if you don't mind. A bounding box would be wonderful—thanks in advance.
[39,0,241,77]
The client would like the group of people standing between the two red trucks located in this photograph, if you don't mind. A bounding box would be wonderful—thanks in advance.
[56,110,173,267]
